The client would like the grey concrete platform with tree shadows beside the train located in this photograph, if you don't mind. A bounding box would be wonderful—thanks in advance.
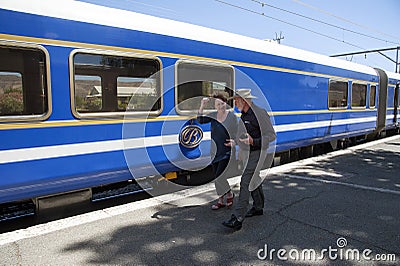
[0,136,400,265]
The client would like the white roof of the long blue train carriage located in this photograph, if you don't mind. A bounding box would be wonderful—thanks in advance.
[0,0,376,75]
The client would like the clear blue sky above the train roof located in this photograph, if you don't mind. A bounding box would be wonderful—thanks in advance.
[81,0,400,72]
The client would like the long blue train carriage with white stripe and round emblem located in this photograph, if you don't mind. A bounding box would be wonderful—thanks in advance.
[0,0,398,217]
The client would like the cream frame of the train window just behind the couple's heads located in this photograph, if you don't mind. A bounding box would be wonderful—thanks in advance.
[174,59,235,115]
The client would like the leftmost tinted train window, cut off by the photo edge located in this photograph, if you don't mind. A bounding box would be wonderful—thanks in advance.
[0,45,50,120]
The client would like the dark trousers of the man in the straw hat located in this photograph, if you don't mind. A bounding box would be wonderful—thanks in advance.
[235,150,266,219]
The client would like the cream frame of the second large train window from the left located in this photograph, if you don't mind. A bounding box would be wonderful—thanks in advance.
[69,49,164,119]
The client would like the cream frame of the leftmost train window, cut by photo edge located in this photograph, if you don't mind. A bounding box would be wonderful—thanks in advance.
[0,41,53,122]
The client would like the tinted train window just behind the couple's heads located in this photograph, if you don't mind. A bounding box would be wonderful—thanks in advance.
[176,62,233,112]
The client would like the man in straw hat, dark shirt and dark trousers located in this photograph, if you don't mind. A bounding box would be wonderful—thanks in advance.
[223,89,276,230]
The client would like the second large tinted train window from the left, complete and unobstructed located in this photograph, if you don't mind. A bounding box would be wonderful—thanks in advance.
[73,53,162,116]
